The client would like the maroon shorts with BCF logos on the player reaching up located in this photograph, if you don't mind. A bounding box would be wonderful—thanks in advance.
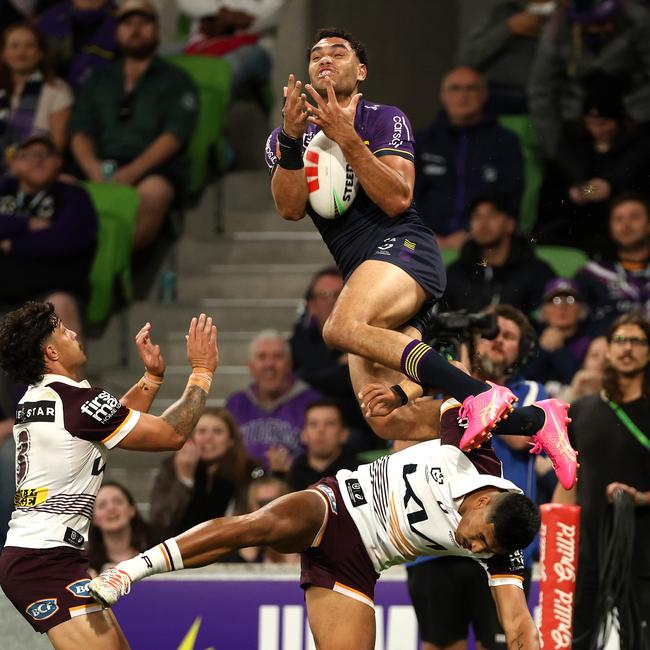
[0,546,101,634]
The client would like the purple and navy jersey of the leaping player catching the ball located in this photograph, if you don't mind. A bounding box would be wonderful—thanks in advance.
[266,99,426,279]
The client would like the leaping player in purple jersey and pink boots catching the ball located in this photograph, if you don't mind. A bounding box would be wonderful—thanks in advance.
[266,29,577,485]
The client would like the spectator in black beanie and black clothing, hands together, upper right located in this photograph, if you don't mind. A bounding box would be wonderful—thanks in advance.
[536,73,650,253]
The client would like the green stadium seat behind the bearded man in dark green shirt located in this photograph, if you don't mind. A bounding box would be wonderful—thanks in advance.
[165,54,230,196]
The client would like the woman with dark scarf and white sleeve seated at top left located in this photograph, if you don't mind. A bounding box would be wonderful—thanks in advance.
[0,23,73,157]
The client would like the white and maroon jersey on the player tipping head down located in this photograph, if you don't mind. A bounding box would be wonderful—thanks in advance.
[336,400,524,587]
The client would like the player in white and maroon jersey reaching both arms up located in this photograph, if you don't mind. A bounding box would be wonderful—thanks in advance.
[0,302,218,650]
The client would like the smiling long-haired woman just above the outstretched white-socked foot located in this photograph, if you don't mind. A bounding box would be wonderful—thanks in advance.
[88,481,164,575]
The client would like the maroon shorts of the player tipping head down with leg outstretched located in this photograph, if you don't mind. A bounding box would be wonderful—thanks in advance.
[300,477,379,607]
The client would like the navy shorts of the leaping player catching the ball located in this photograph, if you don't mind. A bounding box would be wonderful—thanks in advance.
[366,223,447,301]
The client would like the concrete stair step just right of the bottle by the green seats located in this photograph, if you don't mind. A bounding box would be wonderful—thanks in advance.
[177,260,321,302]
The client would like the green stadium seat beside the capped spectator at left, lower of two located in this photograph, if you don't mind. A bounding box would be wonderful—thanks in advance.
[83,181,140,323]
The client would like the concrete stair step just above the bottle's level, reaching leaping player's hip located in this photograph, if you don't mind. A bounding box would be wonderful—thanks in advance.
[177,230,333,273]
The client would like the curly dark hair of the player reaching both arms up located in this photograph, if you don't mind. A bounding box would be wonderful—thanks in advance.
[0,301,59,385]
